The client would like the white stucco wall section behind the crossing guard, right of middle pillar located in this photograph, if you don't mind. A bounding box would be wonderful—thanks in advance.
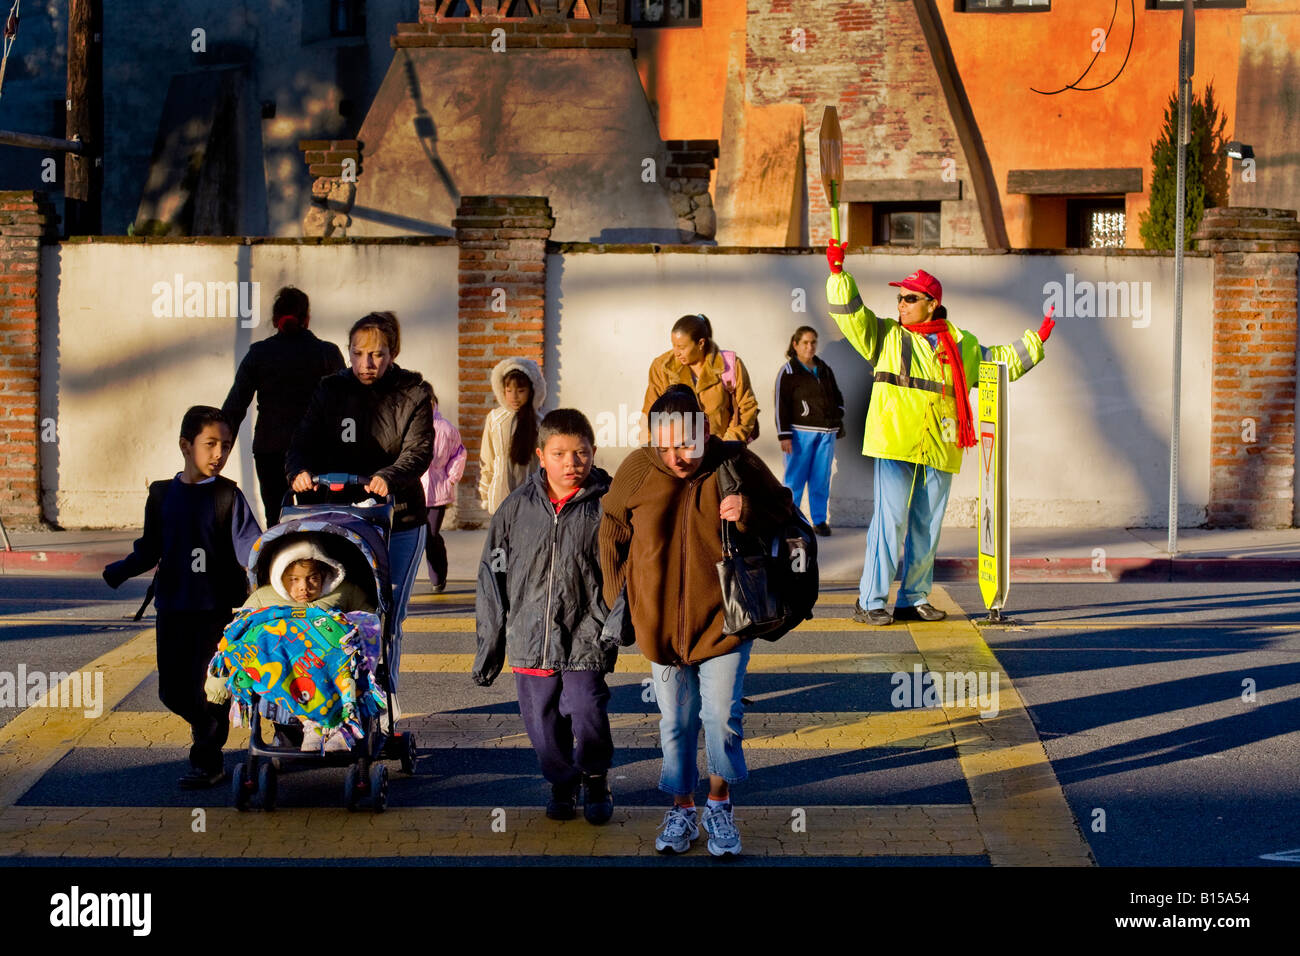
[547,252,1212,527]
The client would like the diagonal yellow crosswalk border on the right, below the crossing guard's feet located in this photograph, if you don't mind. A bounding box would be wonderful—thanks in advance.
[909,585,1095,866]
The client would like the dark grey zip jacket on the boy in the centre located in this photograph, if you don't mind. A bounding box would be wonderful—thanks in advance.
[473,468,618,687]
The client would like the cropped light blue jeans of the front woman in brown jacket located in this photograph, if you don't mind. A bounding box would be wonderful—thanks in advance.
[650,641,754,796]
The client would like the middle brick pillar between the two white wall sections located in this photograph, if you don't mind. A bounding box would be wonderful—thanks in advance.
[452,196,555,528]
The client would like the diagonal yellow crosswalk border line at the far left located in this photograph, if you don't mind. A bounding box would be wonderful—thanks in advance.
[0,631,156,808]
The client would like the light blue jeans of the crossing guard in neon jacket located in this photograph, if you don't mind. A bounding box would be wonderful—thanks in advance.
[858,458,953,611]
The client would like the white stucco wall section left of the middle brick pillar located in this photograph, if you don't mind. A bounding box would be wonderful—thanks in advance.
[40,236,458,528]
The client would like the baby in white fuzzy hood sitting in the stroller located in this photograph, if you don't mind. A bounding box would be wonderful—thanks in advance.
[208,538,376,753]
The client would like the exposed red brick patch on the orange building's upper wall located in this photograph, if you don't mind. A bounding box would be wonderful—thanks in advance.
[745,0,985,246]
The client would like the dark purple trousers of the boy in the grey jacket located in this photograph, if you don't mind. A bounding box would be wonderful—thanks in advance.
[515,671,614,783]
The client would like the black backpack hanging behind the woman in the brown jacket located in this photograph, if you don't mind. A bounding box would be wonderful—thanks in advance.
[718,455,820,641]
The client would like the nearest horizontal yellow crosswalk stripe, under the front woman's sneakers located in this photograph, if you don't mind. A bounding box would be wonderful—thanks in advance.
[0,806,984,860]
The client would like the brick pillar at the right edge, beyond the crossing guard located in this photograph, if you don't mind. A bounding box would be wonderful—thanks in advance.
[1193,207,1300,528]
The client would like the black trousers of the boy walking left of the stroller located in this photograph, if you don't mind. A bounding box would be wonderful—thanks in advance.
[156,611,233,773]
